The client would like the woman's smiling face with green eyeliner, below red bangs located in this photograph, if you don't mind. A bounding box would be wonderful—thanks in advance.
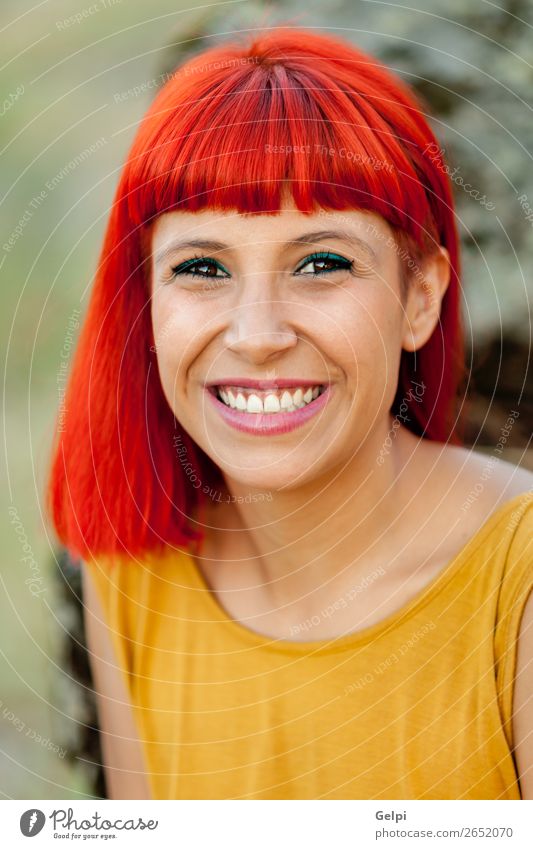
[151,204,436,490]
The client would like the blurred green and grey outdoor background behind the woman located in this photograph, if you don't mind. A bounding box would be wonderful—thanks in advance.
[0,0,533,799]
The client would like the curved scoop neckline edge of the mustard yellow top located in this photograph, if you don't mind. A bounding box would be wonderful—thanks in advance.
[164,492,531,655]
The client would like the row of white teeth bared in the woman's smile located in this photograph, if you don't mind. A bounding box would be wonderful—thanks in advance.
[209,383,326,415]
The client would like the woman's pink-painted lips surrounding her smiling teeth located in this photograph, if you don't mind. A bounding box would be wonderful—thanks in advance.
[205,381,331,436]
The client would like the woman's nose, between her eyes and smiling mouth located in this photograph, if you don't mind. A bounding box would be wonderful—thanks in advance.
[225,277,298,364]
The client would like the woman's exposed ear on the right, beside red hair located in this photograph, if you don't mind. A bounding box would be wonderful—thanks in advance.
[402,245,450,351]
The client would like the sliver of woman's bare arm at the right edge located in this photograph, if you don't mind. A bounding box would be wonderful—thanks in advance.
[513,593,533,799]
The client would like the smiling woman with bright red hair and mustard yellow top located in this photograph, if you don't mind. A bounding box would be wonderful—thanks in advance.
[46,28,533,799]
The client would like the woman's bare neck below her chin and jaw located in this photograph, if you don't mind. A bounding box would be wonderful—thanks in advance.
[210,417,419,603]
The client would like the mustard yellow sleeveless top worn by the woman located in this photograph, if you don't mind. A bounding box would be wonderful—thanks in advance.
[86,492,533,799]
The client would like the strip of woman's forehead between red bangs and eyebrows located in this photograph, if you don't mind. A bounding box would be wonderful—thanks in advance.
[152,202,392,250]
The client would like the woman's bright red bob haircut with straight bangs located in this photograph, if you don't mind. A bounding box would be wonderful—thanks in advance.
[47,26,464,558]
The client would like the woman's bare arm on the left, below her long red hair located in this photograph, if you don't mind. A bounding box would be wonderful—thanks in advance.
[82,566,151,799]
